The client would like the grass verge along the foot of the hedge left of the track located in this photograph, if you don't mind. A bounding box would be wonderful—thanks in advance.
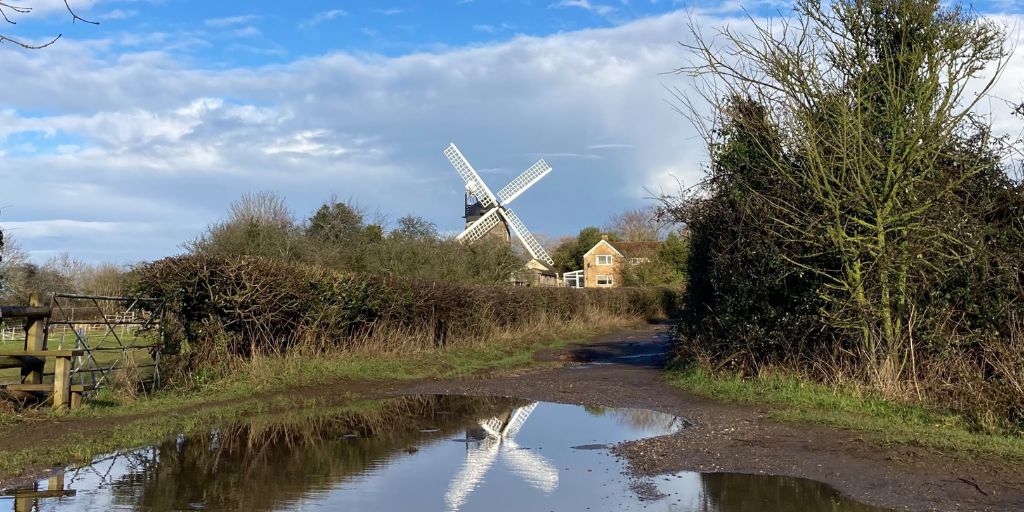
[0,321,635,477]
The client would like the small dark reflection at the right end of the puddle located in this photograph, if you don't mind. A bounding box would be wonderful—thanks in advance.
[700,473,880,512]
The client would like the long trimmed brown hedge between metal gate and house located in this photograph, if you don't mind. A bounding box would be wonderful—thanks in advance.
[134,255,676,356]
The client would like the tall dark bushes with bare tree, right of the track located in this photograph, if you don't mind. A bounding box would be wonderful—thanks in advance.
[665,0,1024,432]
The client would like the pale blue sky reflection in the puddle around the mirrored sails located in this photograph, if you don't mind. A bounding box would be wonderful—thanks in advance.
[284,403,676,511]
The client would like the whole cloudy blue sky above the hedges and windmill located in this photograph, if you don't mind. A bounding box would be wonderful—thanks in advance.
[0,0,1024,263]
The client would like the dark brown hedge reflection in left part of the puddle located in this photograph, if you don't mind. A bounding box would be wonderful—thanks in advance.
[96,396,521,510]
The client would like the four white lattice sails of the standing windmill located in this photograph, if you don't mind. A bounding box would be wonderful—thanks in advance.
[444,144,555,266]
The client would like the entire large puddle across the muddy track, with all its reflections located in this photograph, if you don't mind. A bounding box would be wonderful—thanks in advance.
[0,396,888,512]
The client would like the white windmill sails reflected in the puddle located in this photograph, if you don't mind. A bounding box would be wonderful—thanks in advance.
[444,401,558,512]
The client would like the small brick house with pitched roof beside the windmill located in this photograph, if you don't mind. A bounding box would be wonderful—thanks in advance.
[563,237,662,288]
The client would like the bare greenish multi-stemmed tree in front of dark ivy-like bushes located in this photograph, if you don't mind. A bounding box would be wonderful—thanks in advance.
[680,0,1008,380]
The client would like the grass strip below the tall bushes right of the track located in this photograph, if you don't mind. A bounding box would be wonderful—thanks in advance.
[668,369,1024,461]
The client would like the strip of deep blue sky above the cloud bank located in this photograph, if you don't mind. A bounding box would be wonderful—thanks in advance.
[26,0,704,58]
